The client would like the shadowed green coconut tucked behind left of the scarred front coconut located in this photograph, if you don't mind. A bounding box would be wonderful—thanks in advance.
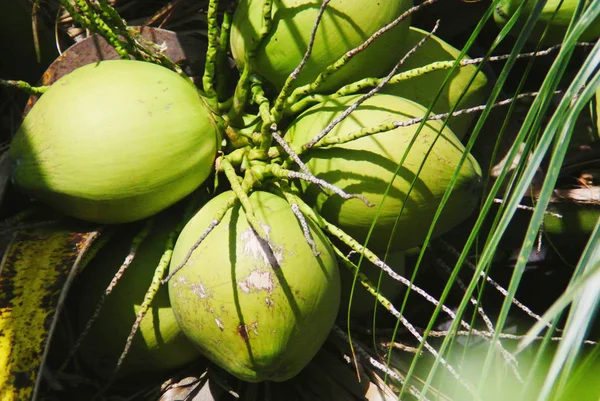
[75,214,201,377]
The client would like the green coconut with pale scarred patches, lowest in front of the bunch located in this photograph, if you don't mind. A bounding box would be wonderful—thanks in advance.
[169,192,340,382]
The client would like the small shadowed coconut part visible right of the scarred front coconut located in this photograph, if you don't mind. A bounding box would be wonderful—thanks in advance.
[340,252,406,317]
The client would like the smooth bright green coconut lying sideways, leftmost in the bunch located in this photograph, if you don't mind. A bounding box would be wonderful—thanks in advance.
[9,60,218,223]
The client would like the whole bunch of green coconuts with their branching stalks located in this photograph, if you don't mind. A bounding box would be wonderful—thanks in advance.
[9,0,487,392]
